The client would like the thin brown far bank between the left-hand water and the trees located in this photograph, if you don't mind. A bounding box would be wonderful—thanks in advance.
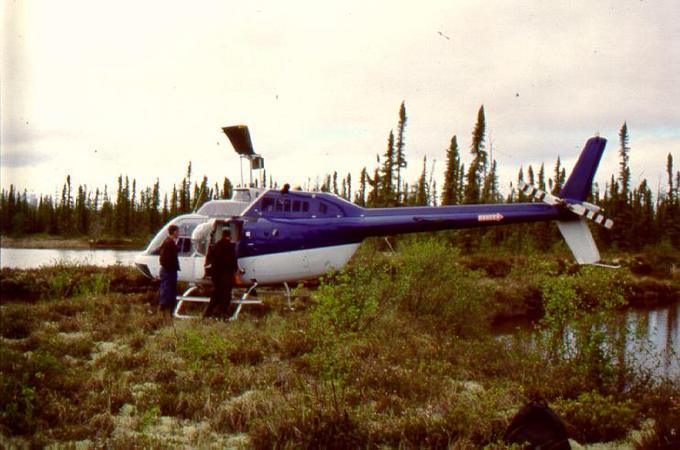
[0,235,146,250]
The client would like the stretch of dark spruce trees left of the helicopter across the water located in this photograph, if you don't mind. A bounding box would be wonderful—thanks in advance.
[0,162,233,238]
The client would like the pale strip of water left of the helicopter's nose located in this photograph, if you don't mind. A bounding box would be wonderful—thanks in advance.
[0,248,140,269]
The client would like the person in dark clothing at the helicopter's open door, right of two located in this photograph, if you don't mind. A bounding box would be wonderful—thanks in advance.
[203,229,236,317]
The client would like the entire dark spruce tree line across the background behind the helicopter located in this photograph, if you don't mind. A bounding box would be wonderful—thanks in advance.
[0,102,680,250]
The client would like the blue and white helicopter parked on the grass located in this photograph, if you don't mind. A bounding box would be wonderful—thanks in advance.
[135,125,613,319]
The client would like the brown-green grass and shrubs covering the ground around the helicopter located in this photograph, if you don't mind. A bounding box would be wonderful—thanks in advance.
[0,240,680,448]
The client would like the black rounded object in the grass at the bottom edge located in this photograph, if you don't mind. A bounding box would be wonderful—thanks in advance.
[503,400,571,450]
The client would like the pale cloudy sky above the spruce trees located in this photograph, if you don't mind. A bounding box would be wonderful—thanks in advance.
[0,0,680,200]
